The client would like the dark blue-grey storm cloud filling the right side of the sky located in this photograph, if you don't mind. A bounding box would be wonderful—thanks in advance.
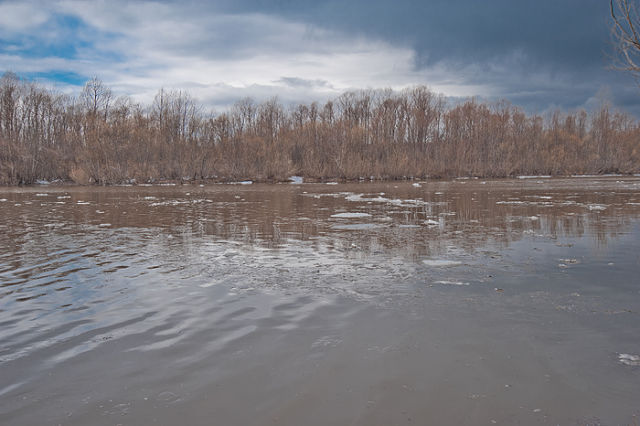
[205,0,640,113]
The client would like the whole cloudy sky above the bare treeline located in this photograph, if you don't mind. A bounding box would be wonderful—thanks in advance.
[0,0,640,116]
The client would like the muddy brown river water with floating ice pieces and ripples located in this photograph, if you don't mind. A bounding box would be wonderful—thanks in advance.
[0,177,640,426]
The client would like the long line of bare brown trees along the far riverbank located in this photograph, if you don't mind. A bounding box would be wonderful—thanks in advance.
[0,73,640,185]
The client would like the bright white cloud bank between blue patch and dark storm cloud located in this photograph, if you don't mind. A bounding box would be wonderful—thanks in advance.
[0,0,492,107]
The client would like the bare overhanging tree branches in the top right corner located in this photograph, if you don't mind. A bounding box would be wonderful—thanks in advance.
[610,0,640,79]
